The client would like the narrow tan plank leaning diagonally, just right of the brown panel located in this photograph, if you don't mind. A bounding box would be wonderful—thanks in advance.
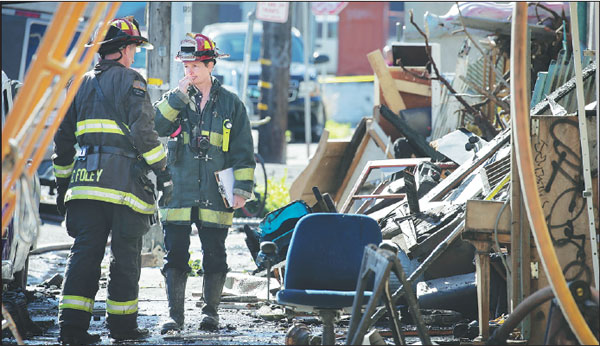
[334,119,393,205]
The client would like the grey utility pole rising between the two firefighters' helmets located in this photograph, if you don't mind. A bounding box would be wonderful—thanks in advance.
[146,1,171,102]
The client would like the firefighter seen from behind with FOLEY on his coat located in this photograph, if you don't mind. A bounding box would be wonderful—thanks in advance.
[53,17,171,345]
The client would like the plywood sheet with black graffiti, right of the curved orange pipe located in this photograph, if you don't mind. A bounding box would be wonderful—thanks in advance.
[531,116,597,282]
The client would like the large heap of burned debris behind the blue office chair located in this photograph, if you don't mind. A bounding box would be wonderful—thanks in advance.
[243,4,598,344]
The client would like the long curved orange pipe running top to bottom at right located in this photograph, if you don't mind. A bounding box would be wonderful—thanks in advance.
[510,2,598,345]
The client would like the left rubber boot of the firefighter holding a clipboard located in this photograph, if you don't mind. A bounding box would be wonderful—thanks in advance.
[160,268,188,334]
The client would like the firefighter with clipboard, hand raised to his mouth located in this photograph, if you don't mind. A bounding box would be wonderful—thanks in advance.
[154,33,255,334]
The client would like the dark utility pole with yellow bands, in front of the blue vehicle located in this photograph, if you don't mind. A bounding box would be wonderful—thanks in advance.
[258,9,292,163]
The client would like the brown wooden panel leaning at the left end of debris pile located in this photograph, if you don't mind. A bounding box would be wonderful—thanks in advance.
[290,130,350,205]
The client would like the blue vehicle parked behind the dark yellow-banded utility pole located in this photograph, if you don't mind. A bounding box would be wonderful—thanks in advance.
[202,22,329,141]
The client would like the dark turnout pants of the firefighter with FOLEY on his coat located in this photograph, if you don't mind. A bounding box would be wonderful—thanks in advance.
[58,200,150,331]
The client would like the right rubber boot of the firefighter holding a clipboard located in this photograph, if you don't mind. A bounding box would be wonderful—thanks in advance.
[200,272,227,330]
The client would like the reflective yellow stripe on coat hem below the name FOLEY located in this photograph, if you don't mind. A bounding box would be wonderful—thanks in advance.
[65,186,156,214]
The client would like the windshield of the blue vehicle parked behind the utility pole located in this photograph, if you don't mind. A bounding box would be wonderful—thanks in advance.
[214,32,304,63]
